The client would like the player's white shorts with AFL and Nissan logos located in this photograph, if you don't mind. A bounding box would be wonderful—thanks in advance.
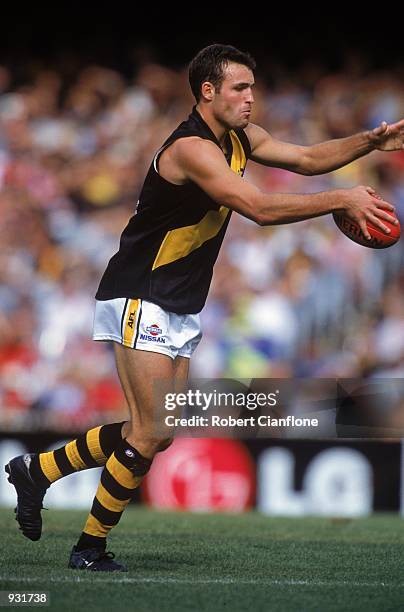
[93,298,202,359]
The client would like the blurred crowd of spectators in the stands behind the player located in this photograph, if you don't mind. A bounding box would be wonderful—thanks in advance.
[0,52,404,429]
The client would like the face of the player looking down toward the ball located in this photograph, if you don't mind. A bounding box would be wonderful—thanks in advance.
[212,62,254,129]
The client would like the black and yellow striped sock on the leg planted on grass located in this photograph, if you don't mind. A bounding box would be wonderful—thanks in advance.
[77,440,152,550]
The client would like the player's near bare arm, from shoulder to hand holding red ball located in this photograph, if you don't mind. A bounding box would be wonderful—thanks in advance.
[173,138,395,237]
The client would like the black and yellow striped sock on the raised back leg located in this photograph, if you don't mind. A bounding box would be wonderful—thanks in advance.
[29,422,124,487]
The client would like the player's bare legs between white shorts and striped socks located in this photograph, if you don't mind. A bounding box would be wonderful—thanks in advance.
[114,342,189,458]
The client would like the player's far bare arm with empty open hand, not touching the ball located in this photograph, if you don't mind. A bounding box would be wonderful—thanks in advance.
[245,119,404,175]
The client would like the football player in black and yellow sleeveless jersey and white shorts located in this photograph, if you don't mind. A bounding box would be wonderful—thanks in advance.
[6,44,404,571]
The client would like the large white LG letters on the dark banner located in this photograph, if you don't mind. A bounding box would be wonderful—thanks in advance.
[258,447,373,516]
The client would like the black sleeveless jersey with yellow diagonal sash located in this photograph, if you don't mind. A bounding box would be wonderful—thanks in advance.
[95,107,251,314]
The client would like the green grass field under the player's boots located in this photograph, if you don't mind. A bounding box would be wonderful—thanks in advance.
[0,509,404,612]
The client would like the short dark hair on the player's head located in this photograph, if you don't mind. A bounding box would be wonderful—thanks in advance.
[189,44,256,102]
